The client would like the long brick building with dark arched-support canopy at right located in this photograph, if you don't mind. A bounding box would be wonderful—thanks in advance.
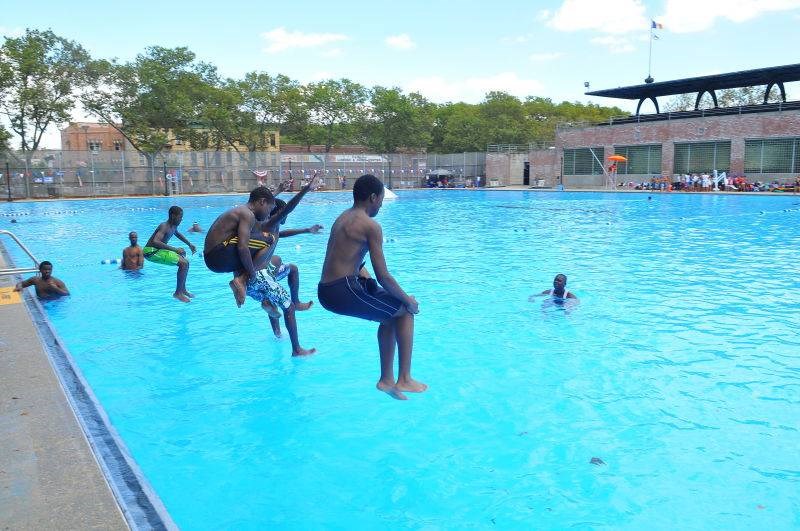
[512,65,800,188]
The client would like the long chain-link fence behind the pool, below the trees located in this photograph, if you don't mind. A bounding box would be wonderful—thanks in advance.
[0,150,486,199]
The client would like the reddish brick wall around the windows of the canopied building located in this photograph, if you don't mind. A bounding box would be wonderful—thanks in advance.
[549,111,800,186]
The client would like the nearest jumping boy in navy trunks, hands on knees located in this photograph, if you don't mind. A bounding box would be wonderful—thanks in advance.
[317,175,428,400]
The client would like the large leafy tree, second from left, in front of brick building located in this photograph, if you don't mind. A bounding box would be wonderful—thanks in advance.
[82,46,219,177]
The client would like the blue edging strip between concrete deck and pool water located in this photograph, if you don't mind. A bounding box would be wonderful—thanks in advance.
[0,242,179,531]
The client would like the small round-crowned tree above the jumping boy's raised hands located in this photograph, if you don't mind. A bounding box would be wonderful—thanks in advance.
[304,79,367,153]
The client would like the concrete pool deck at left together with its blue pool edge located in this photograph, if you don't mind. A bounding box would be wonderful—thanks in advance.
[0,247,176,530]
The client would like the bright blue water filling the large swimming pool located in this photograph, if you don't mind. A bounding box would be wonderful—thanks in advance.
[0,191,800,529]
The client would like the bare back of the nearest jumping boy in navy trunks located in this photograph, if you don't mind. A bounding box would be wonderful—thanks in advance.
[320,208,380,282]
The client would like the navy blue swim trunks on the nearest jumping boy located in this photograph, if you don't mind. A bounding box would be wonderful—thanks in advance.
[317,276,403,323]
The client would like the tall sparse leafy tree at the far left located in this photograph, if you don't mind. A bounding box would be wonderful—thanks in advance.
[0,29,95,167]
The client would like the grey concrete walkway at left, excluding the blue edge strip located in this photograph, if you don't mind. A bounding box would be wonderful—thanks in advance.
[0,256,128,530]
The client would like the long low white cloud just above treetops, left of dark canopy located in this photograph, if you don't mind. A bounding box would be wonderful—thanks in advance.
[403,72,543,103]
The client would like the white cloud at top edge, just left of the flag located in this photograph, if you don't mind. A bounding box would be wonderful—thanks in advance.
[546,0,648,34]
